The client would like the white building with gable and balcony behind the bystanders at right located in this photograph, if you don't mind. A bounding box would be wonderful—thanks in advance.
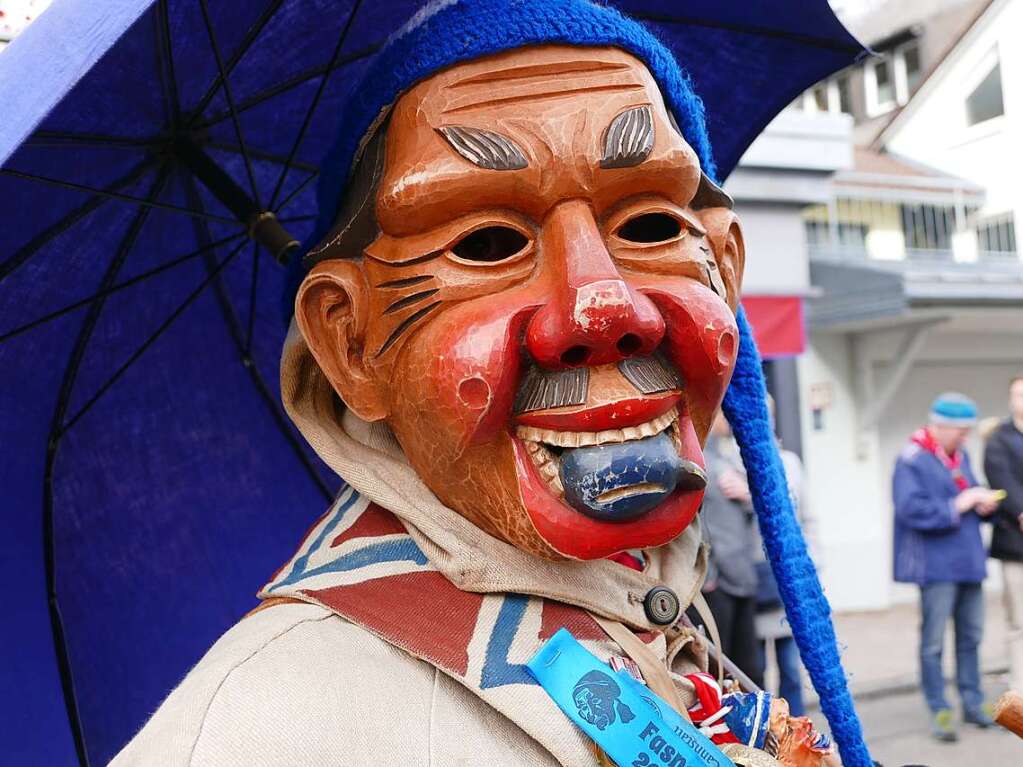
[795,0,1023,610]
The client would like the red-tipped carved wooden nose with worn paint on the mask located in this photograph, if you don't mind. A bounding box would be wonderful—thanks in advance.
[526,200,664,369]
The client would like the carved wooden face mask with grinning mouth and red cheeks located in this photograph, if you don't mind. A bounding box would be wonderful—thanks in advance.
[297,46,744,559]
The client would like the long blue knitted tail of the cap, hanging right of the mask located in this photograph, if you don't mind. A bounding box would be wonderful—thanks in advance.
[722,309,874,767]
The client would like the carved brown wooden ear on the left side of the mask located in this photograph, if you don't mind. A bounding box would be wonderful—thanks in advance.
[295,259,388,421]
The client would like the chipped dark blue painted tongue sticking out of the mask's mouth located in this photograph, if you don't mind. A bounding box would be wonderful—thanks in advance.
[561,432,684,522]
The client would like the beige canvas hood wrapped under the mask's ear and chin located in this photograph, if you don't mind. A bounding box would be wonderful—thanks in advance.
[280,321,707,629]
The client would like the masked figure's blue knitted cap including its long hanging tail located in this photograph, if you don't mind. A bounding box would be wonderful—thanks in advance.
[287,0,873,767]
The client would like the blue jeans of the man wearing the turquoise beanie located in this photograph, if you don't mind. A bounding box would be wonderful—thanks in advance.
[920,583,984,712]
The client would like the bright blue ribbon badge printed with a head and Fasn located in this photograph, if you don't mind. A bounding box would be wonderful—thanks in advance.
[526,629,735,767]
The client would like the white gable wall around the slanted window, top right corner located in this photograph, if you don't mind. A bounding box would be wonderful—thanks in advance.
[884,0,1023,230]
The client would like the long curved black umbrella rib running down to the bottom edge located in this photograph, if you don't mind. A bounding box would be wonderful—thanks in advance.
[43,167,169,767]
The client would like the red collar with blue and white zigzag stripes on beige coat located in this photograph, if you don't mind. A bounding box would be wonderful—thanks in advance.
[260,486,688,764]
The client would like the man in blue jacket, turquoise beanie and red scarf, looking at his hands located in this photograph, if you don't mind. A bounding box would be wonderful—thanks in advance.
[892,392,999,741]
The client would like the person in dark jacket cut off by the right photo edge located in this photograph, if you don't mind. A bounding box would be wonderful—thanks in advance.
[984,374,1023,690]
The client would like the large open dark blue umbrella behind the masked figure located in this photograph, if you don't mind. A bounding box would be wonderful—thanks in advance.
[0,0,862,764]
